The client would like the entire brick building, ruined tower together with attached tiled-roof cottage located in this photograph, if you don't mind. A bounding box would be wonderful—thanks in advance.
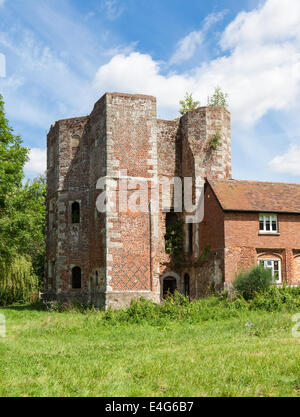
[44,93,300,308]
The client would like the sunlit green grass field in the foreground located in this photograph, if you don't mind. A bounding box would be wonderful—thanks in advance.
[0,300,300,396]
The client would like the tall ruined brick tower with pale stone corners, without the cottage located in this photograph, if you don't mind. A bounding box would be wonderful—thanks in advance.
[44,93,231,308]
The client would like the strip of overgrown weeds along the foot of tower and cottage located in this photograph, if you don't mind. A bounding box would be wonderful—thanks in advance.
[103,286,300,326]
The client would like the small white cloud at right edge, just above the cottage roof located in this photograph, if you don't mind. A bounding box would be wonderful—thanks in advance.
[268,144,300,175]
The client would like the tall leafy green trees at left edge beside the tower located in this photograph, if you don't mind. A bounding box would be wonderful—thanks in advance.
[0,95,46,304]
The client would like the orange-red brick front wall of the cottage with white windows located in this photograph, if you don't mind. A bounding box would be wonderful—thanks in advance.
[225,212,300,284]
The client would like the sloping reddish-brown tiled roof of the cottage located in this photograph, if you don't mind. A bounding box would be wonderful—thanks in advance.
[208,179,300,213]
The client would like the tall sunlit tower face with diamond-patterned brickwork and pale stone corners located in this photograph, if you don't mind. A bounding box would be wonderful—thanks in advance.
[106,94,161,305]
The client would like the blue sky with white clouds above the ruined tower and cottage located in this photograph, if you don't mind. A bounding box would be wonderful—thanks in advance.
[0,0,300,182]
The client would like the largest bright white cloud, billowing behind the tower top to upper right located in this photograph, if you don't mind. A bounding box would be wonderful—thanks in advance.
[95,0,300,127]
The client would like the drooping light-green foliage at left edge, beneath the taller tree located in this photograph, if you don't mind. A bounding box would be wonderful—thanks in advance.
[0,256,38,305]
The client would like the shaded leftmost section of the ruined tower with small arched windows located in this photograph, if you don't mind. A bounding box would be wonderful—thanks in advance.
[46,117,89,293]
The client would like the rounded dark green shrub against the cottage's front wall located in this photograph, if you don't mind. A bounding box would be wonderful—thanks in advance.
[233,266,273,300]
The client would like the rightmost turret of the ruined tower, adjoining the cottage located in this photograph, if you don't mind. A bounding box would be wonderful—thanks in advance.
[180,107,232,297]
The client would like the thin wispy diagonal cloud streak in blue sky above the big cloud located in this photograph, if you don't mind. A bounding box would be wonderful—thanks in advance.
[170,12,225,65]
